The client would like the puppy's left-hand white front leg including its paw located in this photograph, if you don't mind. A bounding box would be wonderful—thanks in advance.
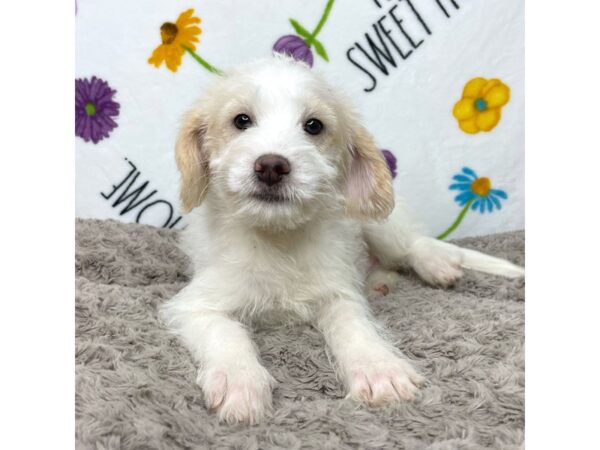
[163,298,275,424]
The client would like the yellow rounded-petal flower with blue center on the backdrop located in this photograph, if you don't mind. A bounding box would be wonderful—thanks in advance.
[452,78,510,134]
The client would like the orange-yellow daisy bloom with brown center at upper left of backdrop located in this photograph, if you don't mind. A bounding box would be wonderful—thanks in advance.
[148,9,202,72]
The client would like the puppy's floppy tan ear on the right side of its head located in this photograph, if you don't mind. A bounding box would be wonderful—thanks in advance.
[346,125,394,219]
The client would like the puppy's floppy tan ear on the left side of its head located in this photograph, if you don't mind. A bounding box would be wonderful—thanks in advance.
[175,111,208,212]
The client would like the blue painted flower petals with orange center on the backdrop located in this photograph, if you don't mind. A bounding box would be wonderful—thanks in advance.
[450,167,508,213]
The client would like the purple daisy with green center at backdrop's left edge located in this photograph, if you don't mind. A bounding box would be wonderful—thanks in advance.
[75,77,119,144]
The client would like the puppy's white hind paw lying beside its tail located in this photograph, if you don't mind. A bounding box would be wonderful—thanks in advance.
[409,238,463,287]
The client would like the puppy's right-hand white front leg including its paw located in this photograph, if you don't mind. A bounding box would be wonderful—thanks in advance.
[317,300,425,406]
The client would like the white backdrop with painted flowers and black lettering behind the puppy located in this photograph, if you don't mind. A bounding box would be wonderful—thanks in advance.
[75,0,524,237]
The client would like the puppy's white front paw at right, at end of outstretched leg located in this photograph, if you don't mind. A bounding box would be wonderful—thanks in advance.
[347,357,425,407]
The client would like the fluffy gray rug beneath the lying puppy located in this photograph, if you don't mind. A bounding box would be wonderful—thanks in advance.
[76,220,524,450]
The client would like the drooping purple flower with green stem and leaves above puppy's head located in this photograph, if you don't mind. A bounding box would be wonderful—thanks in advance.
[273,0,334,67]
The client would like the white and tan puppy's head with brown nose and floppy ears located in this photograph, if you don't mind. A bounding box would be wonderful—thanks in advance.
[176,57,394,228]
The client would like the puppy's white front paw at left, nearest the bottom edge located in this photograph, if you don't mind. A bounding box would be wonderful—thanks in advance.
[197,364,275,425]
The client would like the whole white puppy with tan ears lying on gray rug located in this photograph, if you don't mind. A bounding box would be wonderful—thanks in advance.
[161,57,523,423]
